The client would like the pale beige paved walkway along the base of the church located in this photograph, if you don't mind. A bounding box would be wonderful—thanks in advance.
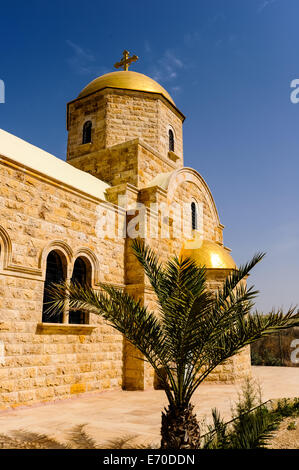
[0,367,299,448]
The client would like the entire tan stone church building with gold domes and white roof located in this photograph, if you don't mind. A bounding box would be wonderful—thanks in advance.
[0,55,250,409]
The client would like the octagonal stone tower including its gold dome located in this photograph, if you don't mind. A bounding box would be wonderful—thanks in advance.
[67,71,185,188]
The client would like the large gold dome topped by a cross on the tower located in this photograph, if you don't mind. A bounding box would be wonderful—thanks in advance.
[78,70,175,104]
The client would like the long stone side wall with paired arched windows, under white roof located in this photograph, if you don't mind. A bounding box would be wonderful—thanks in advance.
[0,160,124,408]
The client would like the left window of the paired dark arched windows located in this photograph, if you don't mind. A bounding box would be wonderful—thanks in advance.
[42,251,65,323]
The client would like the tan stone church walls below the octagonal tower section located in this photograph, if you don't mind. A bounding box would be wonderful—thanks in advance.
[0,139,250,408]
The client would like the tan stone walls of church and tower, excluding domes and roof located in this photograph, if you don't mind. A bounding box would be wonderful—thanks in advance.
[0,80,250,409]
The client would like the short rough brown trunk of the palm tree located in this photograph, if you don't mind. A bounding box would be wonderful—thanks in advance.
[161,403,200,449]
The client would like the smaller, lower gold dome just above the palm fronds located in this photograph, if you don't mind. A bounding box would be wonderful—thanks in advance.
[181,238,237,269]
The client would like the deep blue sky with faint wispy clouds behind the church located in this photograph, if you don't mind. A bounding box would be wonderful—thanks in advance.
[0,0,299,311]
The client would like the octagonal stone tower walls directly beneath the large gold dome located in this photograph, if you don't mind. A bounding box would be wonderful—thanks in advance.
[67,89,183,162]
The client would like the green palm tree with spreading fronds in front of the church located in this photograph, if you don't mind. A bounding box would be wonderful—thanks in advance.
[45,239,299,449]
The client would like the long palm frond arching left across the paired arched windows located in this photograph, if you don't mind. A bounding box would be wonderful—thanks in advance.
[48,282,179,399]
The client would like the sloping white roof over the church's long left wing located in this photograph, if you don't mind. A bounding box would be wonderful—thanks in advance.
[0,129,110,200]
